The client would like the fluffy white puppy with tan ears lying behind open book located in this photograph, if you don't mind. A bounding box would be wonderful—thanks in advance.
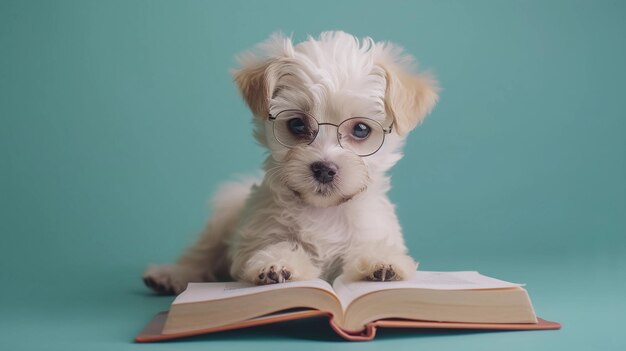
[143,32,437,293]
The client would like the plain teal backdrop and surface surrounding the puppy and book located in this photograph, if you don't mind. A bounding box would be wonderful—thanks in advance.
[0,0,626,350]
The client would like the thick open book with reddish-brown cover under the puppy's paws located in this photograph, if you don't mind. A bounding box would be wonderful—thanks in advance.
[136,271,560,342]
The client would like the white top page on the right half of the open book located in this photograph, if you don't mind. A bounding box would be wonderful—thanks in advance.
[333,271,523,311]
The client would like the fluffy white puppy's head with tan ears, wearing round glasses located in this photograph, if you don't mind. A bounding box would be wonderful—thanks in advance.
[233,32,437,207]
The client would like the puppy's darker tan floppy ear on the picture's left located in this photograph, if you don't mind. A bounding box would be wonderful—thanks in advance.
[232,59,273,119]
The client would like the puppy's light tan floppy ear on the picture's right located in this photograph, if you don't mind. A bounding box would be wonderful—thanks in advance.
[383,65,439,136]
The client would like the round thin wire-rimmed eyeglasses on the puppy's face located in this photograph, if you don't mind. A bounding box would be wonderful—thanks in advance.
[269,110,393,157]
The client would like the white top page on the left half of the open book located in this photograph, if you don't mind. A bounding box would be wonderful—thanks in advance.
[172,279,335,305]
